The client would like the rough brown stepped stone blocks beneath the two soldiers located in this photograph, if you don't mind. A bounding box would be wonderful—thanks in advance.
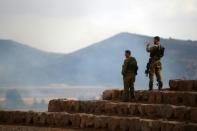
[0,80,197,131]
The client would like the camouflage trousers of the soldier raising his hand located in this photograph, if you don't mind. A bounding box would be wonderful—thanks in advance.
[149,61,163,89]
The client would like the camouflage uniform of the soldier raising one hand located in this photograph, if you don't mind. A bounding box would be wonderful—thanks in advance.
[146,44,163,90]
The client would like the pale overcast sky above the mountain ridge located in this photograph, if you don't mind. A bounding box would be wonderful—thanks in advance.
[0,0,197,53]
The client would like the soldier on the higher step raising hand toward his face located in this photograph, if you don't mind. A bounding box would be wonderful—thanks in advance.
[145,36,165,90]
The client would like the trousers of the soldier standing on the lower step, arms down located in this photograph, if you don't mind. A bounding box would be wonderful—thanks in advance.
[123,75,135,101]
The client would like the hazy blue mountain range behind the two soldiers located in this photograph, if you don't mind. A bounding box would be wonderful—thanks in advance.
[0,33,197,87]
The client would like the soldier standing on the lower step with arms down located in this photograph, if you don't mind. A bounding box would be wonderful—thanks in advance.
[122,50,138,102]
